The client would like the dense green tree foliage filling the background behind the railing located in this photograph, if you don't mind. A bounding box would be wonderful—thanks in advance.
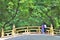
[0,0,60,29]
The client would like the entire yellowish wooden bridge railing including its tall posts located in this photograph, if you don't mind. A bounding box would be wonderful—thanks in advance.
[1,25,60,37]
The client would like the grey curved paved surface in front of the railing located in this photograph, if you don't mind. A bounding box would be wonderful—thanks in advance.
[3,34,60,40]
